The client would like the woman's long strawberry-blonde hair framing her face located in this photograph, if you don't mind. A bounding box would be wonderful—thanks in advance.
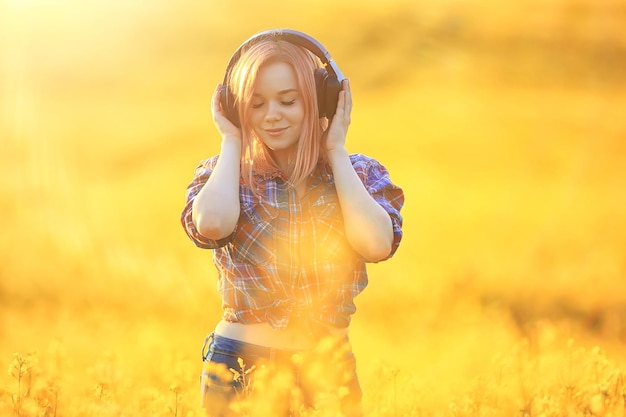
[228,38,328,193]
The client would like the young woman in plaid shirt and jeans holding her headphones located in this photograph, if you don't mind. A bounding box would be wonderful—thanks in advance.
[181,30,404,416]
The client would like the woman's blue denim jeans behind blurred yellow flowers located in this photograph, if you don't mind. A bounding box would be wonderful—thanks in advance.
[200,334,362,417]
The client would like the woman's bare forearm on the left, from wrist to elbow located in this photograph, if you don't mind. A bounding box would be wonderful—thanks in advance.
[192,137,241,240]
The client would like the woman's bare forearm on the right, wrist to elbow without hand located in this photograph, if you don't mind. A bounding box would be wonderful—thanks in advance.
[327,148,393,261]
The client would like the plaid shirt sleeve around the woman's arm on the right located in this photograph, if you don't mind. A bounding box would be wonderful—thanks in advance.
[351,154,404,260]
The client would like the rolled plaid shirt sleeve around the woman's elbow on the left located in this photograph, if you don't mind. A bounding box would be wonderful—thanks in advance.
[180,157,232,249]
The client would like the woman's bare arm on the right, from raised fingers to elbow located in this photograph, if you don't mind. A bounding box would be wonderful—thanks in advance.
[326,81,394,262]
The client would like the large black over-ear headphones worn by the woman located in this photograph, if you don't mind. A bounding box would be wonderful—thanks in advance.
[220,29,345,127]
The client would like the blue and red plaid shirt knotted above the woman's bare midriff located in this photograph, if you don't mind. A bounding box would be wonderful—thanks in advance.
[181,154,404,329]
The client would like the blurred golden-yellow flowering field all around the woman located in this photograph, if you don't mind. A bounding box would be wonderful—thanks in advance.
[0,0,626,417]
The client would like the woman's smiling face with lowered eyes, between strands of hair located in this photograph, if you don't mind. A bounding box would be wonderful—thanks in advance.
[248,62,304,167]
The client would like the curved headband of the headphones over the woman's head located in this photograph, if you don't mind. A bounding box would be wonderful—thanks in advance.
[224,29,345,84]
